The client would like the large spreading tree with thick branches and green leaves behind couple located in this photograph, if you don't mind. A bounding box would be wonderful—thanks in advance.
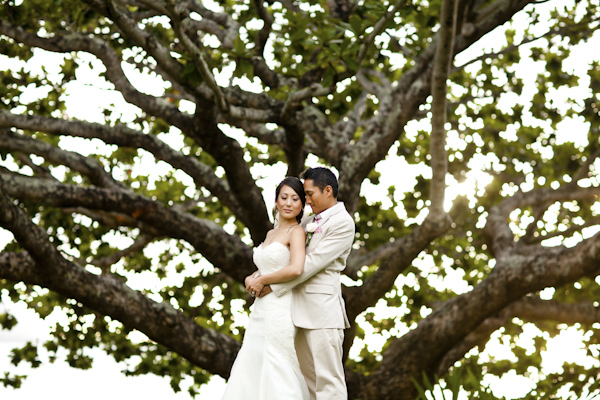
[0,0,600,400]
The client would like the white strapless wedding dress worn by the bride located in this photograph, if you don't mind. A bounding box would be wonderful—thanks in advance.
[223,242,309,400]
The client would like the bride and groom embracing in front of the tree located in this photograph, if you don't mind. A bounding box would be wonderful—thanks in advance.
[223,167,354,400]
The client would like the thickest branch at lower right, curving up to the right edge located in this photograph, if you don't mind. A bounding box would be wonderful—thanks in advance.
[356,228,600,398]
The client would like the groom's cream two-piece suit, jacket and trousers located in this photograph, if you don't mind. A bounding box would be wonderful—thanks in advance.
[271,202,355,400]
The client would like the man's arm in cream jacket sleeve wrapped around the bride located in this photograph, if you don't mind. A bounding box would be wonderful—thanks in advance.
[271,212,354,296]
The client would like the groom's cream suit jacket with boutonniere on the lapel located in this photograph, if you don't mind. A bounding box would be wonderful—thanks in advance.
[271,202,355,329]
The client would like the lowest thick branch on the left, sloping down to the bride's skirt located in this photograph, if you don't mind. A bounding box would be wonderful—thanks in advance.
[0,248,240,378]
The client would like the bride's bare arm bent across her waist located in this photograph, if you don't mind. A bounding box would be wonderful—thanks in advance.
[250,226,306,293]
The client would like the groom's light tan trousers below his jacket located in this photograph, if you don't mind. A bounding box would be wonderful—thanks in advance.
[295,328,348,400]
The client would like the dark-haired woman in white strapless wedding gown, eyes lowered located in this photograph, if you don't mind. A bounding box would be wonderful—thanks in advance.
[223,177,309,400]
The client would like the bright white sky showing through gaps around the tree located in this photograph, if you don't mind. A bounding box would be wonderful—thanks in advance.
[0,0,600,400]
